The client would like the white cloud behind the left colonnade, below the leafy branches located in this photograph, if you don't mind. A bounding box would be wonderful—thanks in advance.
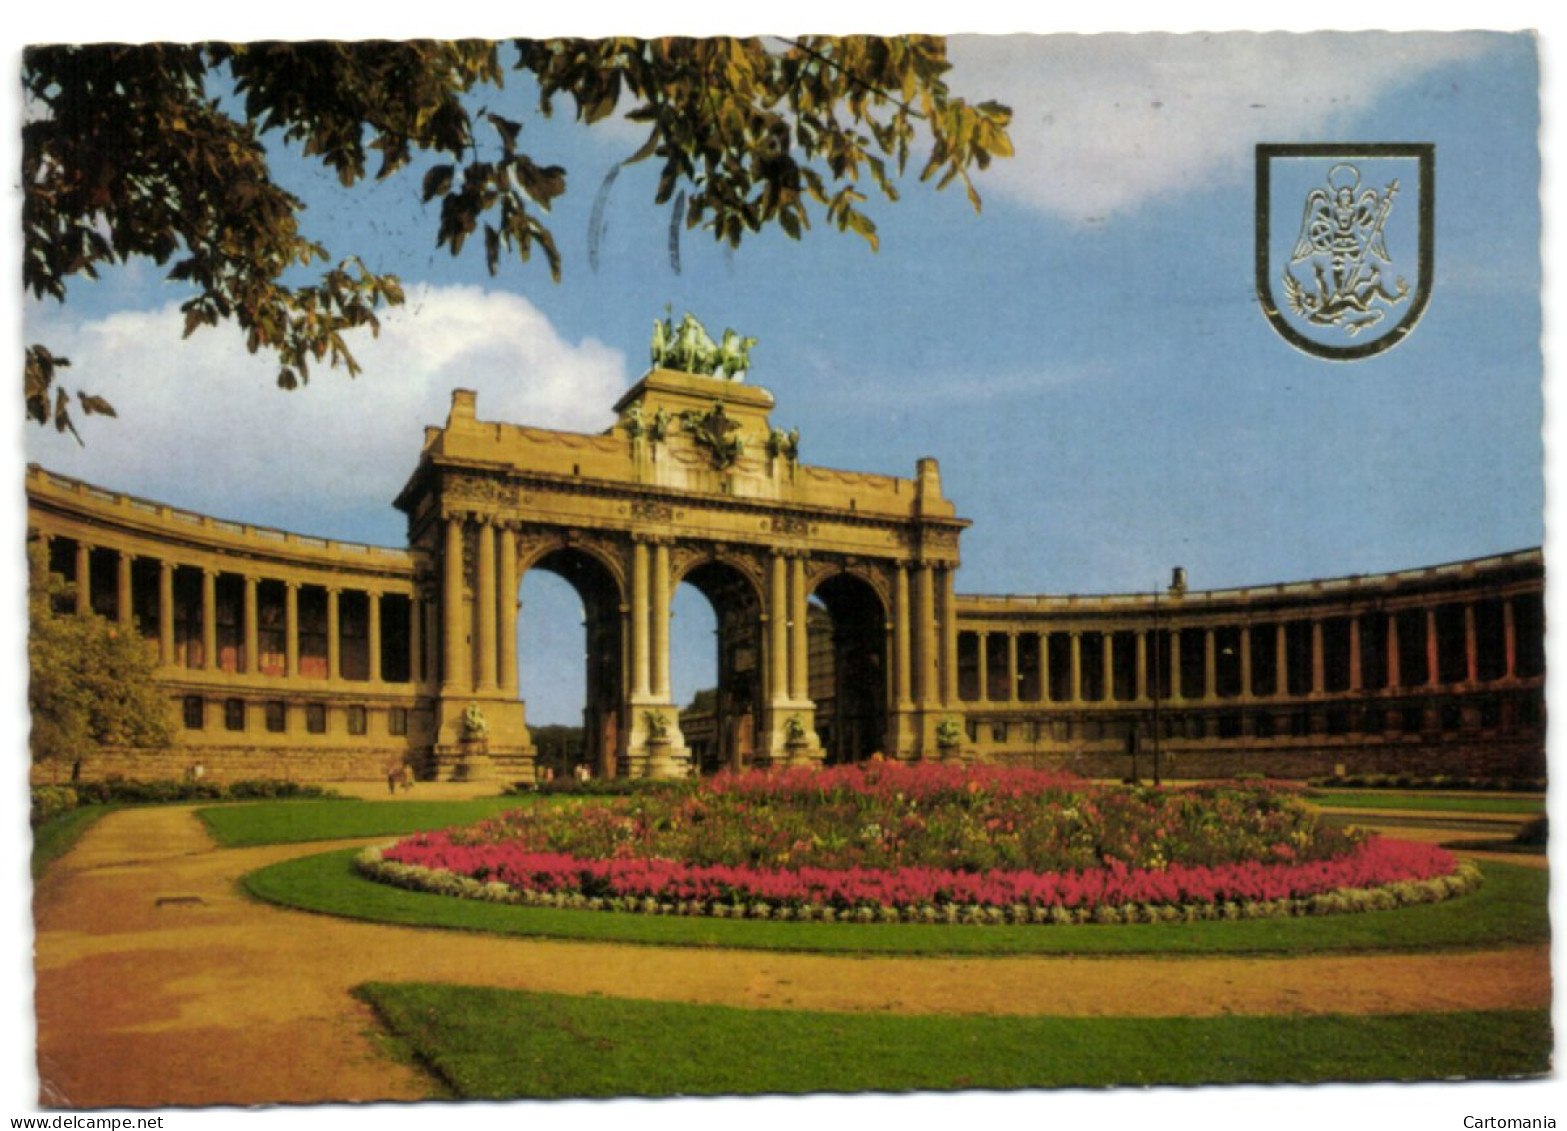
[28,287,627,537]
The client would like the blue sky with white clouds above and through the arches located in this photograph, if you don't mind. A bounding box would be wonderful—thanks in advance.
[25,33,1543,719]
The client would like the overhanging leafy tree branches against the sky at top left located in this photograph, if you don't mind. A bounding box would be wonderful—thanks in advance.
[22,36,1012,439]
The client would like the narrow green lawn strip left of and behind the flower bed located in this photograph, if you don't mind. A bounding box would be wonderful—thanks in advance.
[197,797,539,847]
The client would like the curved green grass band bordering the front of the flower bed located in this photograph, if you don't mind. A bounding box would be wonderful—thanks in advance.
[244,849,1550,956]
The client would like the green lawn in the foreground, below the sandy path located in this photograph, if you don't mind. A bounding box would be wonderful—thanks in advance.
[359,984,1551,1100]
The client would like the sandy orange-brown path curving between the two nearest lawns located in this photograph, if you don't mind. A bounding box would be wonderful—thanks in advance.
[34,807,1550,1108]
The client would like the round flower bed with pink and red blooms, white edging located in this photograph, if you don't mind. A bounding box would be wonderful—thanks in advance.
[360,764,1478,923]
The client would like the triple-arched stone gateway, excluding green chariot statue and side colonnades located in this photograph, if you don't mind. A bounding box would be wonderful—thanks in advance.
[396,358,968,777]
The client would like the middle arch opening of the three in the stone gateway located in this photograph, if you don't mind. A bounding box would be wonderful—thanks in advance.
[672,561,763,774]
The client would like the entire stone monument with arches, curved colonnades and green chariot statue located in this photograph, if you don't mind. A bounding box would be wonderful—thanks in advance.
[27,316,1545,782]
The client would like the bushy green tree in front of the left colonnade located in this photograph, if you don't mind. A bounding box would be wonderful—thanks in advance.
[27,540,172,766]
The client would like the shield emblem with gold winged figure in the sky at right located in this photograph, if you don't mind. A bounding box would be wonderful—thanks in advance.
[1257,144,1435,360]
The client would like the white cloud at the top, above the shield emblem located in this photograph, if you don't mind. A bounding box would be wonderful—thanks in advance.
[951,31,1495,221]
